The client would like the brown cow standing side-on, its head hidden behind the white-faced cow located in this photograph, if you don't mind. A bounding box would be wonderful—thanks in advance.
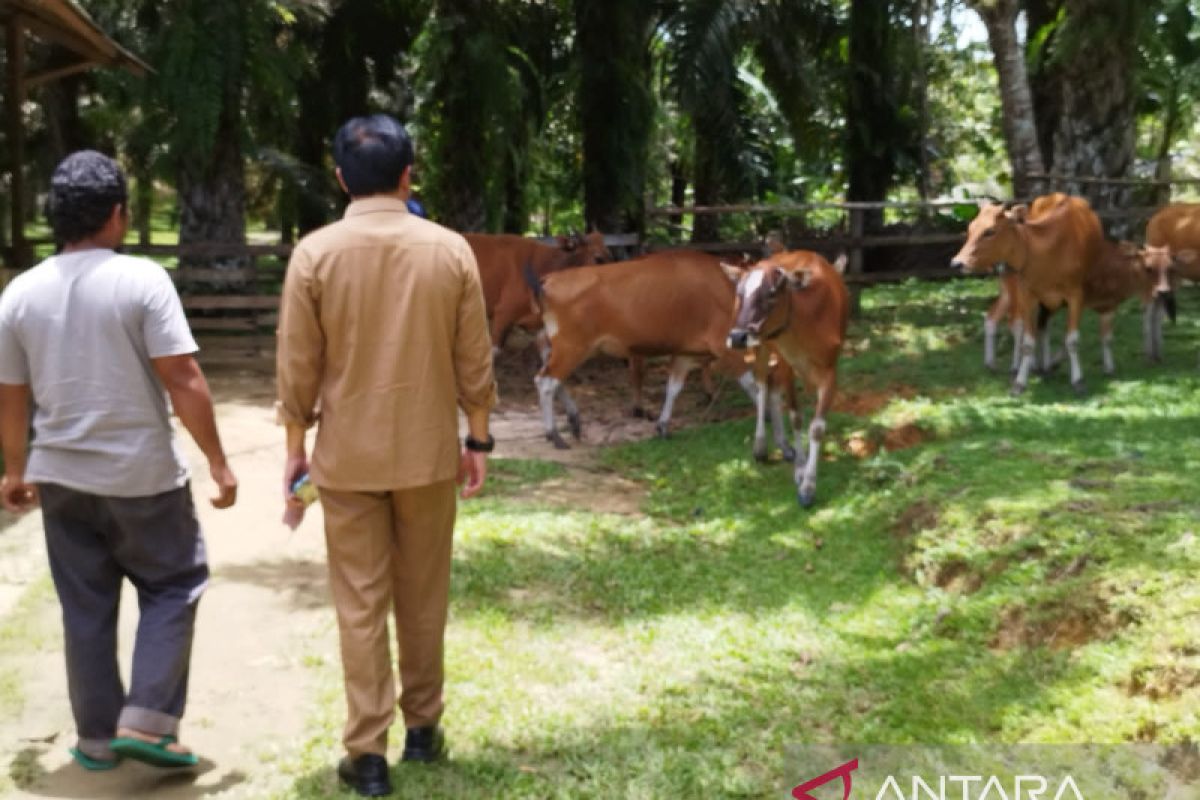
[529,249,748,449]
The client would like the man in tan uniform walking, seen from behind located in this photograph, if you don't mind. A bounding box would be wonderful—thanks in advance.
[277,115,496,796]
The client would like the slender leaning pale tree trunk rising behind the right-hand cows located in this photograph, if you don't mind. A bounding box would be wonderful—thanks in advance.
[971,0,1045,198]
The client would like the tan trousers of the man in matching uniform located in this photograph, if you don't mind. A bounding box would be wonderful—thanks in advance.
[319,481,456,758]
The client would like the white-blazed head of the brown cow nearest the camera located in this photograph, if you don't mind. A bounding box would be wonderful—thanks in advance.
[721,259,812,350]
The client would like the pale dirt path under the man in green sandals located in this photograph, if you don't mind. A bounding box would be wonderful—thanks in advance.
[0,378,336,800]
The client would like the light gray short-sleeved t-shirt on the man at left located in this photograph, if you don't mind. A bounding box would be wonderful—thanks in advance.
[0,249,198,498]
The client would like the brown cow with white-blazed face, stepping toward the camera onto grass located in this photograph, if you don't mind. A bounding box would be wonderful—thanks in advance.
[727,249,850,507]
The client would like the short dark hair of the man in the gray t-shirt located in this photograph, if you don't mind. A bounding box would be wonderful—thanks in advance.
[46,150,130,245]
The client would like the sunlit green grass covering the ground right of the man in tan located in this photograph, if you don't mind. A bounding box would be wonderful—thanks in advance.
[278,282,1200,798]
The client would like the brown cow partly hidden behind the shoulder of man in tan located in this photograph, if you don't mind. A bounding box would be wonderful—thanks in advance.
[463,230,612,355]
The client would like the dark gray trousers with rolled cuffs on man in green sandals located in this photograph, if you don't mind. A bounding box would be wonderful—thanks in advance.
[37,483,209,758]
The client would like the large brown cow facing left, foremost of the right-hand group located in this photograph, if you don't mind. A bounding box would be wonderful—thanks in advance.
[950,197,1104,395]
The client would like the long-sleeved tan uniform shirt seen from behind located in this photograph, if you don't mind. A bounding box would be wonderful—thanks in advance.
[277,197,496,492]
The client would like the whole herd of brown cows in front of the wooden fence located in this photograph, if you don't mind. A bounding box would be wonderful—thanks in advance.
[467,199,1200,506]
